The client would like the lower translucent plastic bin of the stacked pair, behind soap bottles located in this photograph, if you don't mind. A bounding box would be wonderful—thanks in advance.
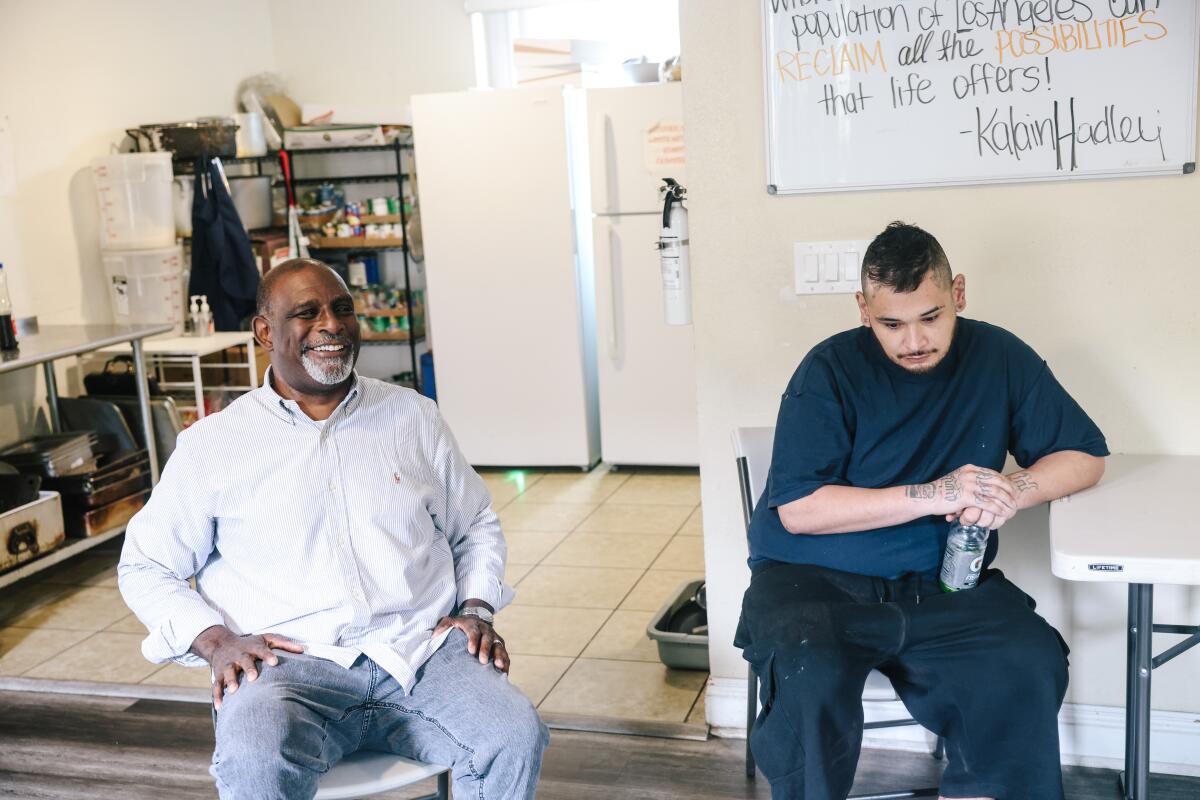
[100,242,184,336]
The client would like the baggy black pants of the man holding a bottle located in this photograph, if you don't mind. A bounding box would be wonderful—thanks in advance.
[736,561,1068,800]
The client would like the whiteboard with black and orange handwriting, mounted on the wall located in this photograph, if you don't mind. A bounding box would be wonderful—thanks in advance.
[761,0,1200,193]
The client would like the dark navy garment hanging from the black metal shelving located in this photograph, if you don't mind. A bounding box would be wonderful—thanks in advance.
[187,158,258,331]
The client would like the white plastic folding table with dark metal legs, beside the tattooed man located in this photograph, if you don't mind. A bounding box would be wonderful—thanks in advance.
[1050,455,1200,800]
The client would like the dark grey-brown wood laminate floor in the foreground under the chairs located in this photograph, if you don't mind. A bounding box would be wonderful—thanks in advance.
[0,692,1200,800]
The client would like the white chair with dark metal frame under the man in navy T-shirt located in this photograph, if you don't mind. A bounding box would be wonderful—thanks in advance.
[733,426,944,800]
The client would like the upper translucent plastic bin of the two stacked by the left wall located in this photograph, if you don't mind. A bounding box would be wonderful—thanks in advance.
[91,152,175,249]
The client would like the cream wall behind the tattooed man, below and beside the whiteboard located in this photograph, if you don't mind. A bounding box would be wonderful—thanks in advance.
[680,0,1200,712]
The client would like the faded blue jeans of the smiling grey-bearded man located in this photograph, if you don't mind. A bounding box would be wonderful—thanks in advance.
[210,630,550,800]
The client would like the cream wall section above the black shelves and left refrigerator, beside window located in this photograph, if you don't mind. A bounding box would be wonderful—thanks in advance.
[270,0,475,121]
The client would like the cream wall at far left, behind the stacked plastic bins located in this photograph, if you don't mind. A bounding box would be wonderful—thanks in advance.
[0,0,275,441]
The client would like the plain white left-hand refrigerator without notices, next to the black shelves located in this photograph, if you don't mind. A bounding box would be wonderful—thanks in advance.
[413,88,600,469]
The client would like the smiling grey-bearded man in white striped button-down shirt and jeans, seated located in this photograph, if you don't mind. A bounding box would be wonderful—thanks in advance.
[119,259,547,800]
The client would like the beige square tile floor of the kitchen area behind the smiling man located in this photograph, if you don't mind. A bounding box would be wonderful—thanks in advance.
[0,467,707,724]
